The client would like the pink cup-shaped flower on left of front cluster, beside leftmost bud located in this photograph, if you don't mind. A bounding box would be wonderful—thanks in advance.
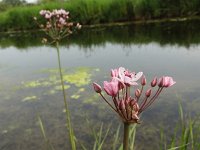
[103,80,119,97]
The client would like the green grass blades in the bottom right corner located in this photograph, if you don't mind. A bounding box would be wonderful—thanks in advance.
[160,102,200,150]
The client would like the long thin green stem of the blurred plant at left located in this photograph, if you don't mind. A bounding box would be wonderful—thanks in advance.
[56,42,76,150]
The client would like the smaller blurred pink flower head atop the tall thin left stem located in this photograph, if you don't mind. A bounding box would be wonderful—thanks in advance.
[34,9,81,41]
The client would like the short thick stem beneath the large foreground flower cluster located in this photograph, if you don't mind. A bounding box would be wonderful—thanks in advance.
[123,122,130,150]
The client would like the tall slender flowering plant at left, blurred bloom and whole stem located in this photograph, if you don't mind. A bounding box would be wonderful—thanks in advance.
[34,9,81,150]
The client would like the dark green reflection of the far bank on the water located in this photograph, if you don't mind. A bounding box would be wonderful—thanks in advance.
[0,20,200,48]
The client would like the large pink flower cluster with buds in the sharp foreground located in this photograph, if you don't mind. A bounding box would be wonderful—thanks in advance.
[93,67,176,123]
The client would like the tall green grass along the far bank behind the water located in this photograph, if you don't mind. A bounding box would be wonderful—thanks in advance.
[0,0,200,31]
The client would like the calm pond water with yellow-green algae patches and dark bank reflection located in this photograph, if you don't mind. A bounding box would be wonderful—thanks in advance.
[0,21,200,150]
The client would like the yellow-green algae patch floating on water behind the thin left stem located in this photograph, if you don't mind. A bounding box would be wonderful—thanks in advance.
[22,67,100,102]
